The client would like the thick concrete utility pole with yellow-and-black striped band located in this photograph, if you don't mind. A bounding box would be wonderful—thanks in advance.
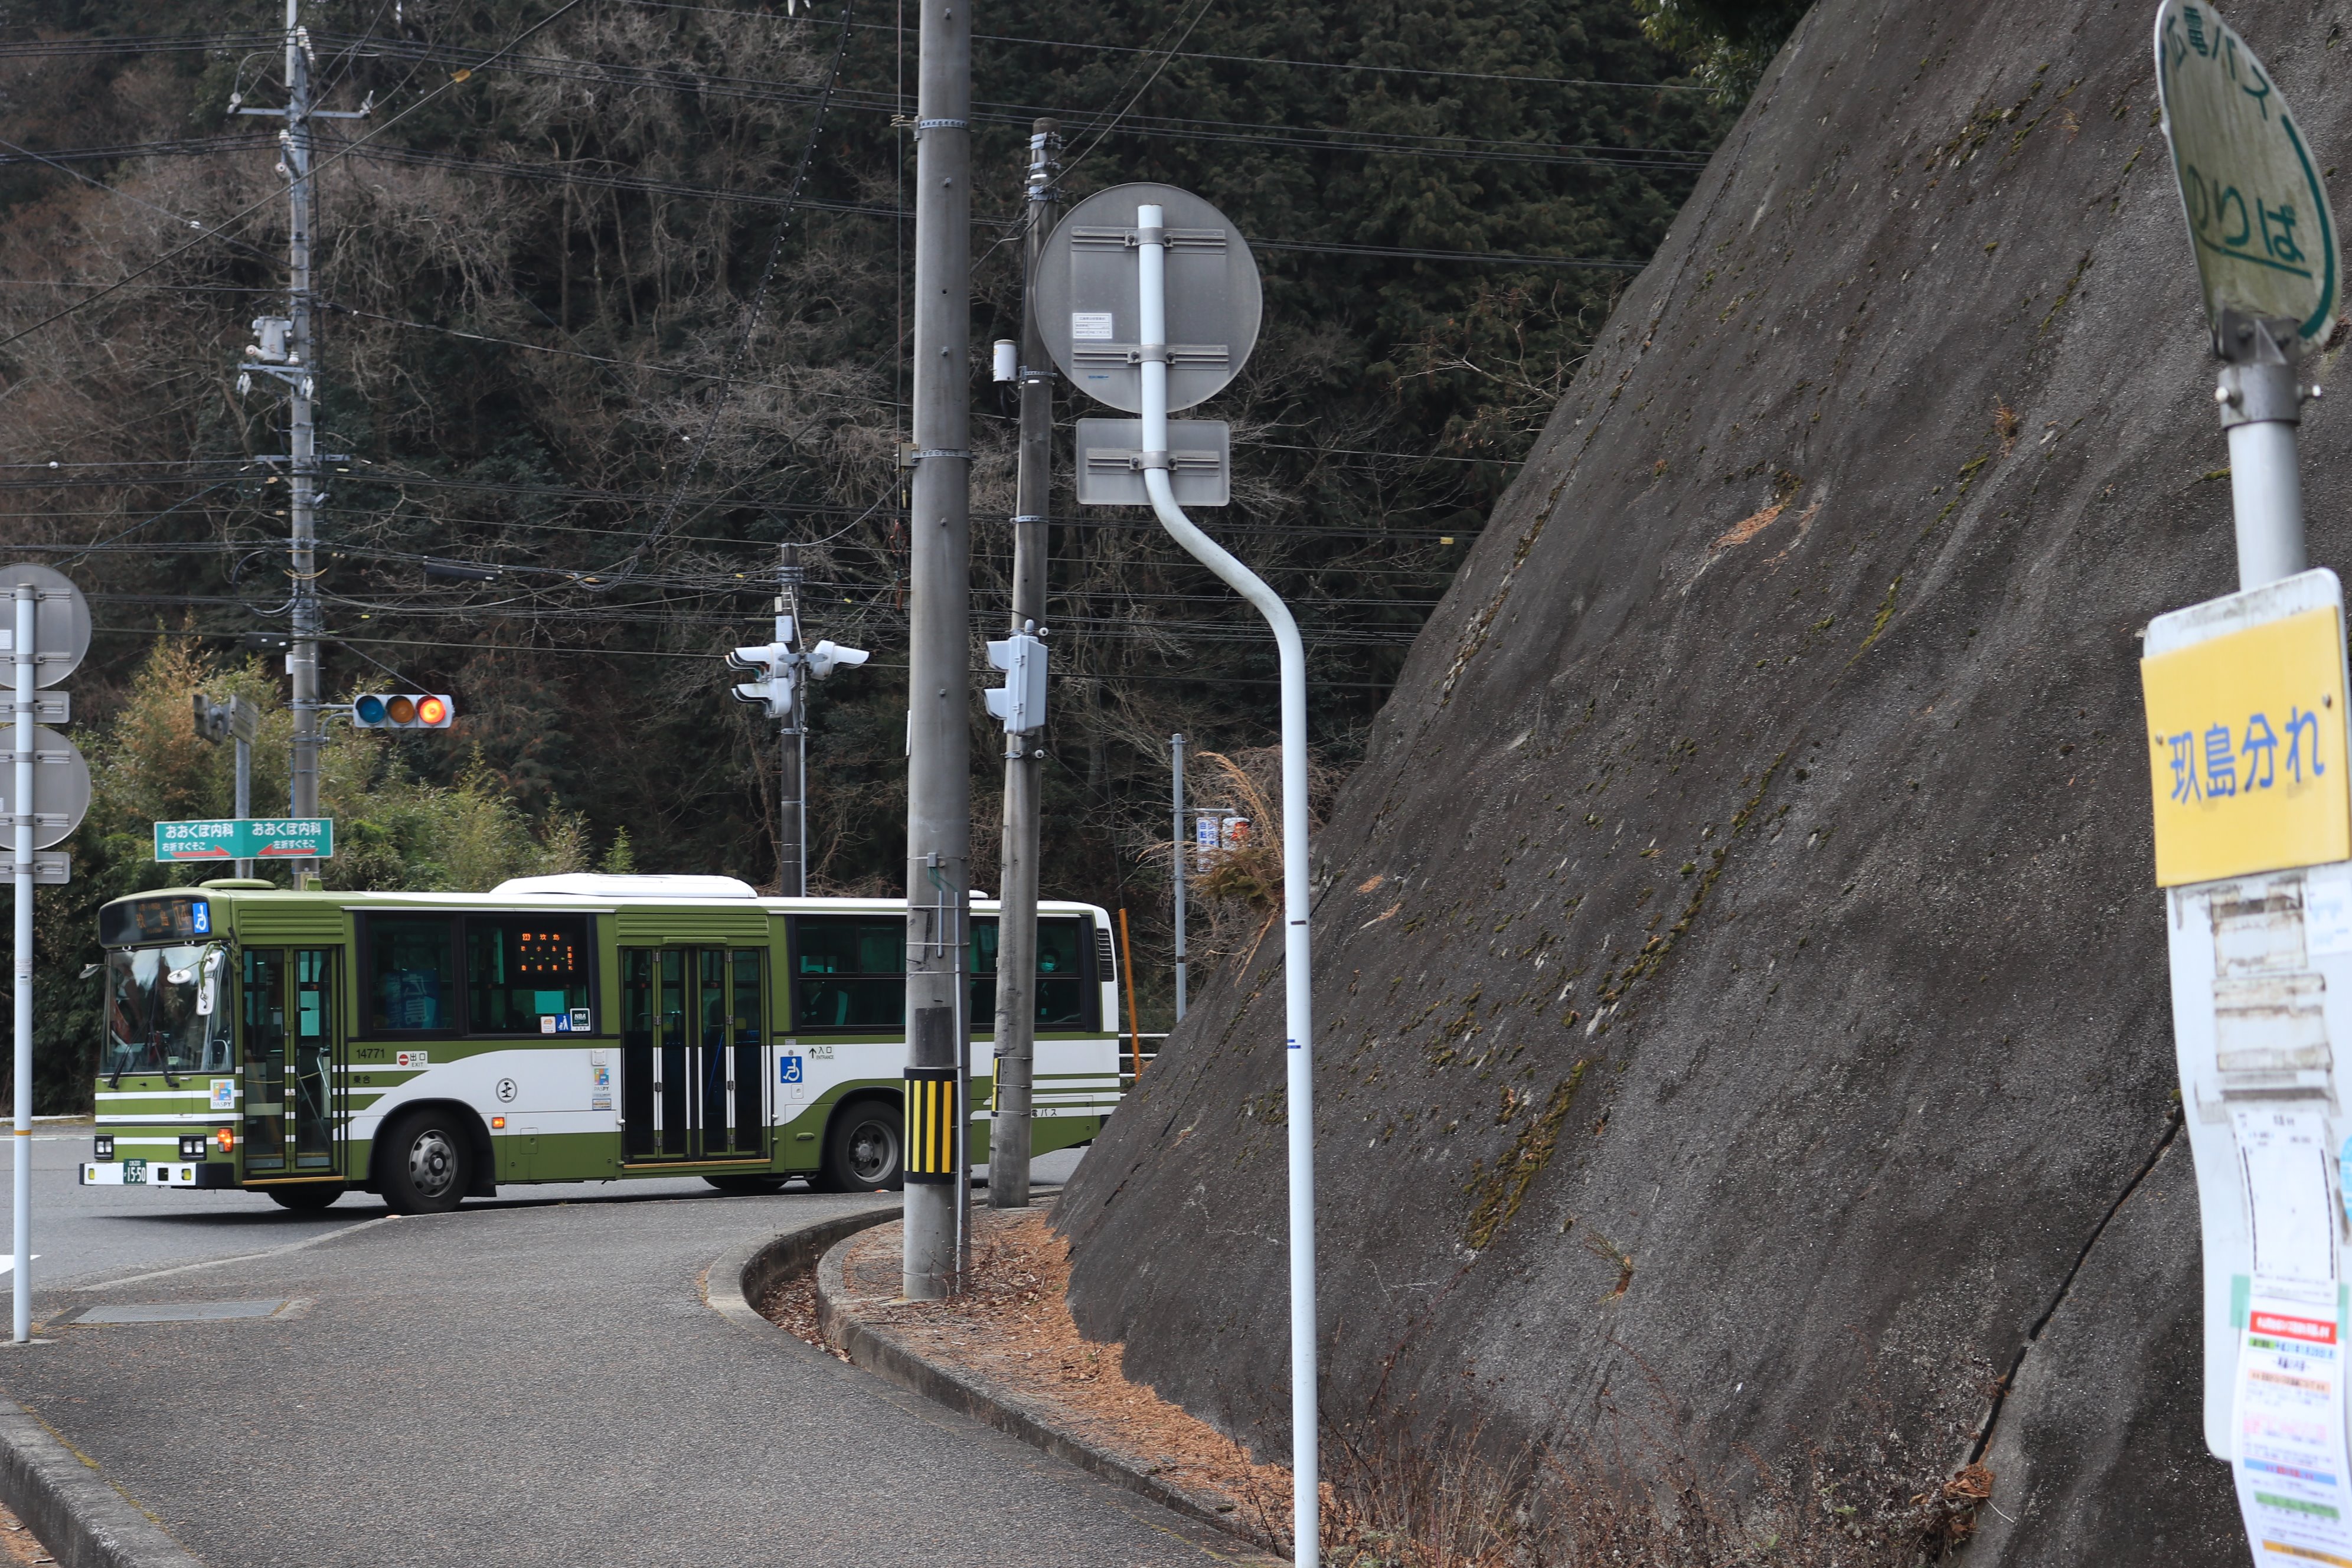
[906,0,971,1300]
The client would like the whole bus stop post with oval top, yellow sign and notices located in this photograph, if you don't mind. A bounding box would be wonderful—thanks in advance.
[2140,0,2352,1568]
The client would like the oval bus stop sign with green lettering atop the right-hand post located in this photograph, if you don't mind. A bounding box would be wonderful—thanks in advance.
[2157,0,2343,345]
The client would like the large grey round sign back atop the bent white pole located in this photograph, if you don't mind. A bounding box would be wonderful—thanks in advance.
[1030,184,1265,414]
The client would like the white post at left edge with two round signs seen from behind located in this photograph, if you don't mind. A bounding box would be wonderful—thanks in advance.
[0,562,89,1345]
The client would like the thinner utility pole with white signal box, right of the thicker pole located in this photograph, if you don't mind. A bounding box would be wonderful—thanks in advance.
[988,120,1061,1208]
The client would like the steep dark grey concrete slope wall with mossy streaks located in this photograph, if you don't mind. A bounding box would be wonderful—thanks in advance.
[1059,0,2352,1563]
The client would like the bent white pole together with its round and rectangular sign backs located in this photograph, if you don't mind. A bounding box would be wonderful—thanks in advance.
[1030,186,1322,1568]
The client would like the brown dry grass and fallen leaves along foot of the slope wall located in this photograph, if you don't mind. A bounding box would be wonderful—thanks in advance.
[760,1208,1992,1568]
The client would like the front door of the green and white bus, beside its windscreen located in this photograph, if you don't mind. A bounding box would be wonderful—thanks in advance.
[240,948,348,1182]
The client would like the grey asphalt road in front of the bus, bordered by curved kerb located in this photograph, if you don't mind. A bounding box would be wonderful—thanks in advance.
[0,1140,1247,1568]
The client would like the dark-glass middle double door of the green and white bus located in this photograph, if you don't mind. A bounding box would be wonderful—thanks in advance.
[621,948,767,1164]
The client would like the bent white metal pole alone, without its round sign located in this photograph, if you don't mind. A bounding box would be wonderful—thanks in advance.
[1136,207,1322,1568]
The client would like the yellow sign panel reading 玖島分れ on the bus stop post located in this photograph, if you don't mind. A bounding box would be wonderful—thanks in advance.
[2140,571,2352,886]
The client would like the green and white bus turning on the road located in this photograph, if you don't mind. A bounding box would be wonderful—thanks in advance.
[80,874,1119,1213]
